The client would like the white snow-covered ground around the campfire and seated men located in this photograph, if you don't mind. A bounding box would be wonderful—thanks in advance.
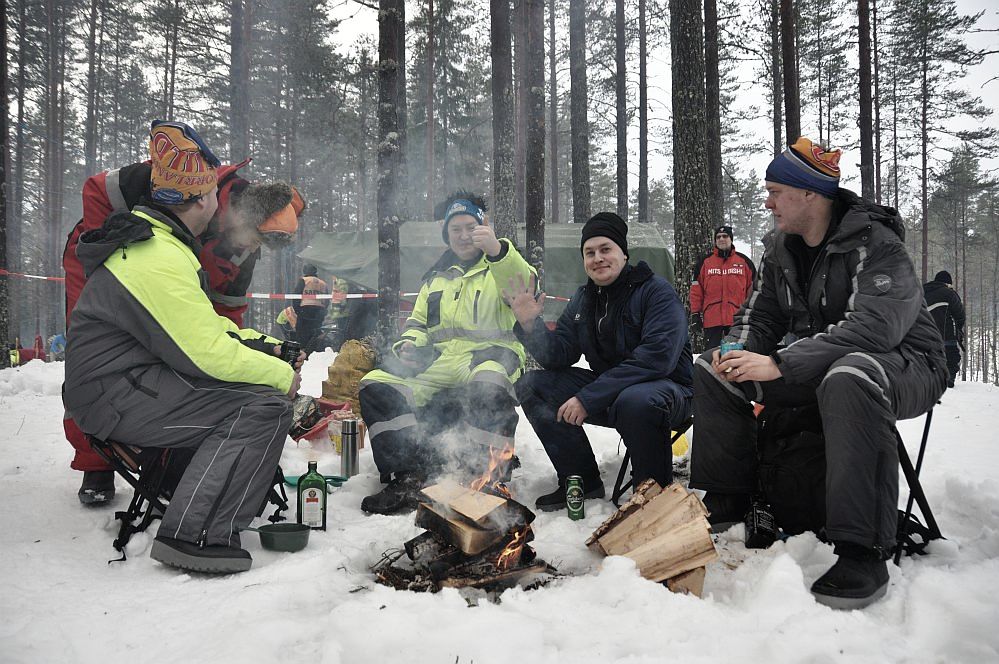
[0,353,999,664]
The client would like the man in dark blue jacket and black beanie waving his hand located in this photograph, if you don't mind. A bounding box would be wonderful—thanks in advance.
[507,212,693,510]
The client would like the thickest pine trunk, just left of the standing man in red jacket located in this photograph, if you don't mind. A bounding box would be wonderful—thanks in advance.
[669,0,711,312]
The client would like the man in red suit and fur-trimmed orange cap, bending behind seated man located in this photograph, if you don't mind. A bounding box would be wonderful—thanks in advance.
[63,127,305,505]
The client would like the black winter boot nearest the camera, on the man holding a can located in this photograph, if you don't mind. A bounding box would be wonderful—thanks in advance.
[812,543,888,611]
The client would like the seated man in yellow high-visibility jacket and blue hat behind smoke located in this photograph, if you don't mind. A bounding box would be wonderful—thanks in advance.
[360,192,537,514]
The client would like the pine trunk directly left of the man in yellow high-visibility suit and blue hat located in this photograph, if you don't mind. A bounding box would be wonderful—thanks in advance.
[377,0,405,348]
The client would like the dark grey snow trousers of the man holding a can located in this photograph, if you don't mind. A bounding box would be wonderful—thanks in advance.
[690,349,946,551]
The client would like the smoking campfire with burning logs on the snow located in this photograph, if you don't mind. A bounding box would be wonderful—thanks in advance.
[373,446,554,592]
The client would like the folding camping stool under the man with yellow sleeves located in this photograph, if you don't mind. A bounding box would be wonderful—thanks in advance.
[87,435,288,564]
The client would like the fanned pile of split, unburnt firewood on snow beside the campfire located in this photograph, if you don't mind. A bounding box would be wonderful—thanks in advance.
[586,480,718,596]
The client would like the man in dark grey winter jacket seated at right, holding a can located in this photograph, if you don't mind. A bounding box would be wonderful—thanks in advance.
[690,137,946,609]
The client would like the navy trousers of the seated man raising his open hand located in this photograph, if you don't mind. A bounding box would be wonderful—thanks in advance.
[517,367,691,486]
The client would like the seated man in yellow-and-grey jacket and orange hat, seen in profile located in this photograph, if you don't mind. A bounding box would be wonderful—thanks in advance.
[63,122,302,573]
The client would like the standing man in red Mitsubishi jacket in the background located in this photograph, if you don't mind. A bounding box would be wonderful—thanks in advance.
[690,226,756,348]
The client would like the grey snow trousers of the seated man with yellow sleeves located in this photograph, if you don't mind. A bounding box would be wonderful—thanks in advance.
[67,365,292,546]
